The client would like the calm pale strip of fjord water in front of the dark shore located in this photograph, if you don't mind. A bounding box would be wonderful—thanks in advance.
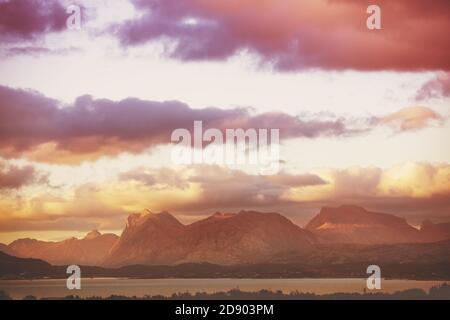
[0,278,444,299]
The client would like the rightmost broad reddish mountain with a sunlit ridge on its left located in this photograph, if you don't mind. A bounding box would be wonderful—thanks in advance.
[305,205,424,244]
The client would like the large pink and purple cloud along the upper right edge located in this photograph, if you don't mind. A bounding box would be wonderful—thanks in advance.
[115,0,450,71]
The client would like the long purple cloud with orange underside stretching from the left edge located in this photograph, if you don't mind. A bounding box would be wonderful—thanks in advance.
[0,86,358,162]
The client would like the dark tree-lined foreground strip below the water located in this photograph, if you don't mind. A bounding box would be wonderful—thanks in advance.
[0,283,450,300]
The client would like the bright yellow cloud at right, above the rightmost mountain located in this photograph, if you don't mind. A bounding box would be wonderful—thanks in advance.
[284,162,450,202]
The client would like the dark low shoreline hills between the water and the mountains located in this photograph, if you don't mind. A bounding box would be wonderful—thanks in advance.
[0,250,450,281]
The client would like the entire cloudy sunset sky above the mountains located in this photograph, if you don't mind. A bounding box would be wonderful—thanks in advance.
[0,0,450,243]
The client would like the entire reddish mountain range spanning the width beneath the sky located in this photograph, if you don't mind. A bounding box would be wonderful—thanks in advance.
[0,205,450,267]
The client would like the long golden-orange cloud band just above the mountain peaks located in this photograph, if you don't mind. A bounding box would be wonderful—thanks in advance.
[0,162,450,236]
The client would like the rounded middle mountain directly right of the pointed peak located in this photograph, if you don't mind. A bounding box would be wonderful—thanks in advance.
[186,211,315,264]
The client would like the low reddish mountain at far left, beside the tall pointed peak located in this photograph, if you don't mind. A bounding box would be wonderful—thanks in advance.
[5,231,119,266]
